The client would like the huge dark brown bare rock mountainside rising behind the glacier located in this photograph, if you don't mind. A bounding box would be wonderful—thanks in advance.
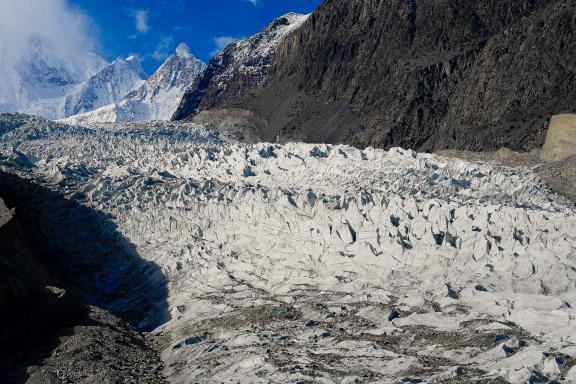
[190,0,576,151]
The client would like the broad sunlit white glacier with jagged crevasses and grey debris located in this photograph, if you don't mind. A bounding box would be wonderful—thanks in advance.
[0,121,576,383]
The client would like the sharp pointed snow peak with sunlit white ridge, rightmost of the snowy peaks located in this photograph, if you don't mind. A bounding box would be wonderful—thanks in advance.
[64,43,205,124]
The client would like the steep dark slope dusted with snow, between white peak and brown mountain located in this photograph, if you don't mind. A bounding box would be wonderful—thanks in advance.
[174,13,307,120]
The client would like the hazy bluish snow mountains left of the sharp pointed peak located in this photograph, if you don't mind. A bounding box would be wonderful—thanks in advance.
[0,39,146,119]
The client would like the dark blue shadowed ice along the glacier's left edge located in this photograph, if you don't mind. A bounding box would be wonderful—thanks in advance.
[0,172,170,330]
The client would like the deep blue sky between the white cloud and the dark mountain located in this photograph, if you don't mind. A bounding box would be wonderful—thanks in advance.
[69,0,322,74]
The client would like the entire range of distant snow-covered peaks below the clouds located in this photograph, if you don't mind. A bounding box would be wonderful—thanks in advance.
[0,36,205,123]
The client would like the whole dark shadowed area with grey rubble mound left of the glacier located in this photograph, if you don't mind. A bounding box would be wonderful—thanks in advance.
[0,172,168,384]
